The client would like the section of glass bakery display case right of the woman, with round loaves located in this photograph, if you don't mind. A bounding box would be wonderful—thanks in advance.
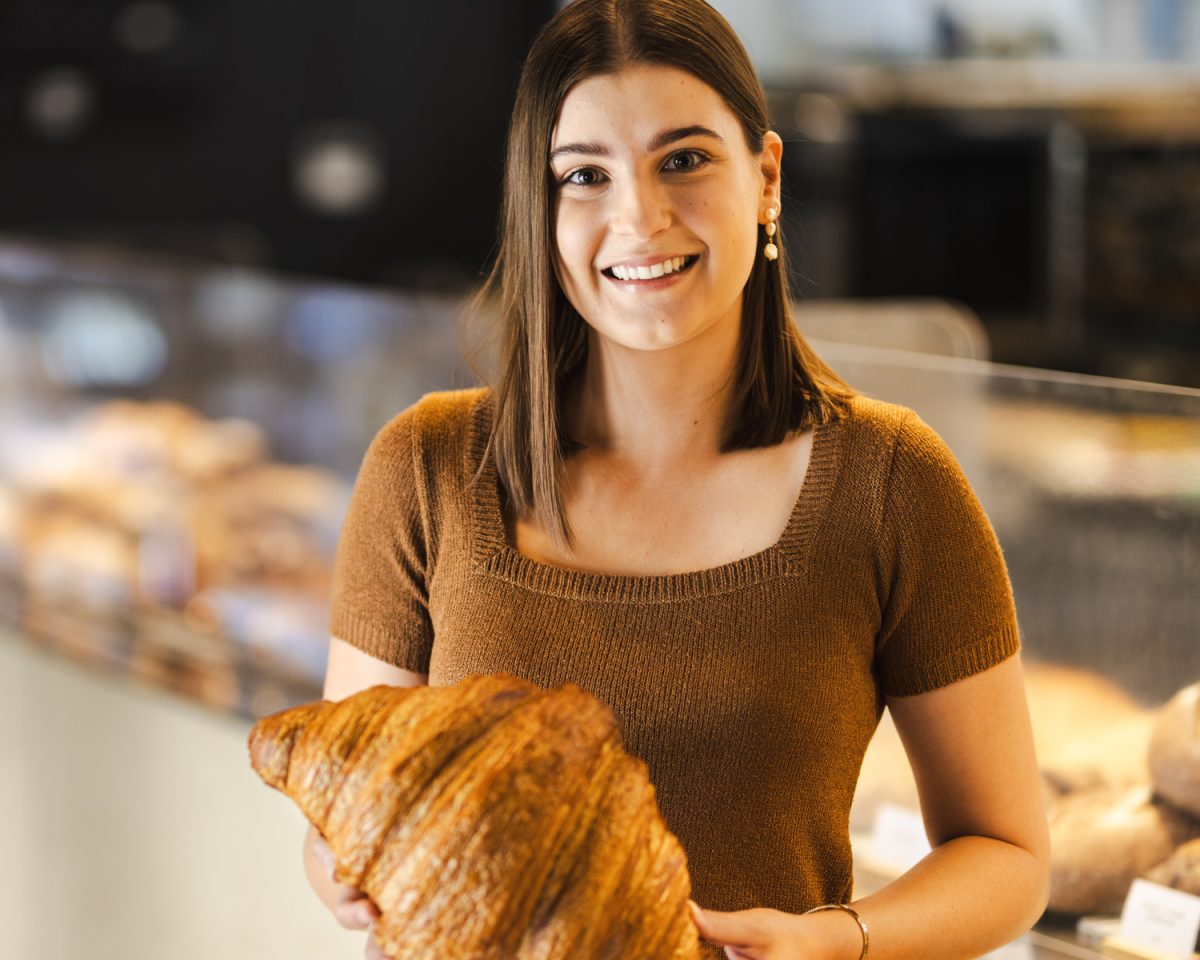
[818,343,1200,956]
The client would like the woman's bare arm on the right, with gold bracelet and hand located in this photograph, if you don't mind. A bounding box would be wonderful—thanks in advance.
[698,656,1050,960]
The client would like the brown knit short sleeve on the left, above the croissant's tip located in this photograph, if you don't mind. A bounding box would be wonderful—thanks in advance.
[330,408,433,673]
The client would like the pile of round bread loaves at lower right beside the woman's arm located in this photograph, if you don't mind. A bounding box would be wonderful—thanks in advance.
[851,662,1200,914]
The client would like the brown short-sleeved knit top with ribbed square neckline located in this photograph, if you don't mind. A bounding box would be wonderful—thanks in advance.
[332,390,1018,912]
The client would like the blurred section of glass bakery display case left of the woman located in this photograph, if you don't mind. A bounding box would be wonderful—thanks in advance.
[0,242,462,716]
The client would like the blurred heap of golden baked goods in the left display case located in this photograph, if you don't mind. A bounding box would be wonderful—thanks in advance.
[0,400,349,706]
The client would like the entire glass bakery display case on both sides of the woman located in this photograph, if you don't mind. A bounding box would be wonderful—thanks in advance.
[0,234,1200,956]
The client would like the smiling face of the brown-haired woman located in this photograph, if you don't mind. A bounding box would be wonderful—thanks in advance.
[550,66,781,350]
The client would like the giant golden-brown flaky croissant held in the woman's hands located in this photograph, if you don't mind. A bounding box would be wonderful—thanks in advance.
[250,676,701,960]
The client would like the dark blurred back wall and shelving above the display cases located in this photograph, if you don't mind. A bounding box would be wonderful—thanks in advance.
[0,0,1200,386]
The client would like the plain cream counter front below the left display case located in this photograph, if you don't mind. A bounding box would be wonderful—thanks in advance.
[0,625,352,960]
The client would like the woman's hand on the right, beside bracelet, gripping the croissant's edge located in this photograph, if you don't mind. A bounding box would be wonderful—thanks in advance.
[691,904,859,960]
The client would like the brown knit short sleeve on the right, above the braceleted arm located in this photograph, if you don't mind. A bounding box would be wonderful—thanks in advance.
[876,412,1020,696]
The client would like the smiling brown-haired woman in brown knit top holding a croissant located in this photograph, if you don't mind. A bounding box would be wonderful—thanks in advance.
[306,0,1048,960]
